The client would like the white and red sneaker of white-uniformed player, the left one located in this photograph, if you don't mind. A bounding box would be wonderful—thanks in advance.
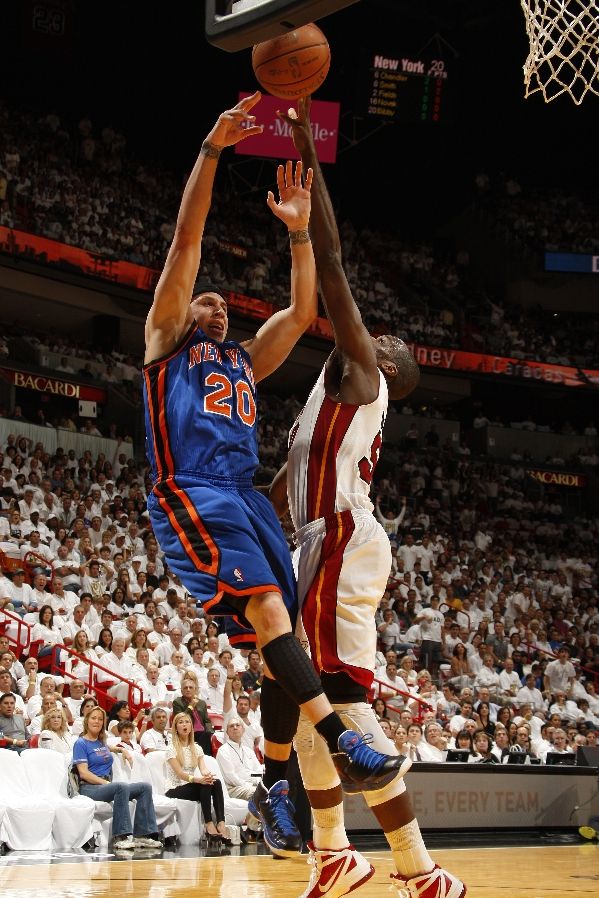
[300,842,374,898]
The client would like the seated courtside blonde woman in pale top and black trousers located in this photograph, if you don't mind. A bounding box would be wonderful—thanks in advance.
[165,711,231,845]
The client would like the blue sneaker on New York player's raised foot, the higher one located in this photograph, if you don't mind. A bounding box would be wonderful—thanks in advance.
[331,730,412,792]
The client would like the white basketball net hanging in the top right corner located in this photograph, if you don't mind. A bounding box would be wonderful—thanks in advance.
[521,0,599,105]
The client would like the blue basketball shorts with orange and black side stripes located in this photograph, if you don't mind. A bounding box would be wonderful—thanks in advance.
[148,475,297,645]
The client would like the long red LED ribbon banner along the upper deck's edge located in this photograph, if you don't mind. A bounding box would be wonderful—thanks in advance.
[0,226,599,386]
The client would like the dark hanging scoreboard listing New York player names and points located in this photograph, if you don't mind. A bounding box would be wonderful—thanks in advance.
[358,52,451,123]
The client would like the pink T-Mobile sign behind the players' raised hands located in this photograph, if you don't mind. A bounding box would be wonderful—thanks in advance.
[235,91,340,162]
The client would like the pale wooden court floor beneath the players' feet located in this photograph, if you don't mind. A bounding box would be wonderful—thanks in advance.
[0,843,599,898]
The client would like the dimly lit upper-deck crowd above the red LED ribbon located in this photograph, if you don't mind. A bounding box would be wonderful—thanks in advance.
[0,105,599,368]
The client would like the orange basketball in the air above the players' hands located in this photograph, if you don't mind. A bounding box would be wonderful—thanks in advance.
[252,24,331,100]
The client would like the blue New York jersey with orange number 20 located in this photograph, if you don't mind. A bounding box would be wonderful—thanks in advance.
[144,324,258,483]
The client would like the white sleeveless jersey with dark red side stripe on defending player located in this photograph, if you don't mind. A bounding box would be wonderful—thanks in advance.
[287,368,389,531]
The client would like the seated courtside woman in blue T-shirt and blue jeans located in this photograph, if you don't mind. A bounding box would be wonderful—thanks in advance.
[73,705,162,851]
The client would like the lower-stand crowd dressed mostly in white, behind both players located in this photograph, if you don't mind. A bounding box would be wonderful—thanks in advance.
[0,400,599,776]
